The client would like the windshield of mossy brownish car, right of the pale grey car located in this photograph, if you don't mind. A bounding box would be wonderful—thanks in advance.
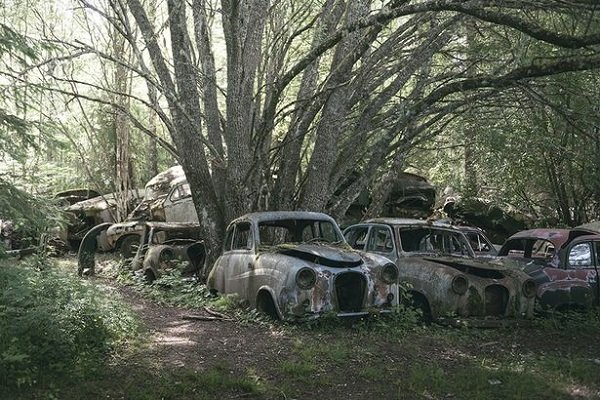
[400,227,471,256]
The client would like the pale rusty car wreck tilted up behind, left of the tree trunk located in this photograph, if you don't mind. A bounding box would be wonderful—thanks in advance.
[104,165,198,258]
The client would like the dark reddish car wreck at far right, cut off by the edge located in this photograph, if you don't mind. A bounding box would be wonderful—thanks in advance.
[498,228,600,311]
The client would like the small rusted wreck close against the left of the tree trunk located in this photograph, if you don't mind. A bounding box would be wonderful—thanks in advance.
[131,222,206,282]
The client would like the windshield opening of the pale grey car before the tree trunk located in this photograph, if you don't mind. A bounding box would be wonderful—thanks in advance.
[258,219,344,246]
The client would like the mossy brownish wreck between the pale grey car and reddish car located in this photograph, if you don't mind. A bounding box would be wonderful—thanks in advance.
[344,218,536,324]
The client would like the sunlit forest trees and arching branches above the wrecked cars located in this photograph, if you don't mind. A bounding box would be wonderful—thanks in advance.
[0,0,600,260]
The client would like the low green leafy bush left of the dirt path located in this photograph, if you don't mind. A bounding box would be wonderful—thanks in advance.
[0,261,140,388]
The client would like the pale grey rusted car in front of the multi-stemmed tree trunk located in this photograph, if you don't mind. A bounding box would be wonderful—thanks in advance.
[208,211,398,320]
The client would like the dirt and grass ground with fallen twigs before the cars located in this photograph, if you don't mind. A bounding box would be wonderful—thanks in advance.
[15,258,600,400]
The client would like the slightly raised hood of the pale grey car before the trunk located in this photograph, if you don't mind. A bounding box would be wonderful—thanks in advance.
[276,244,363,268]
